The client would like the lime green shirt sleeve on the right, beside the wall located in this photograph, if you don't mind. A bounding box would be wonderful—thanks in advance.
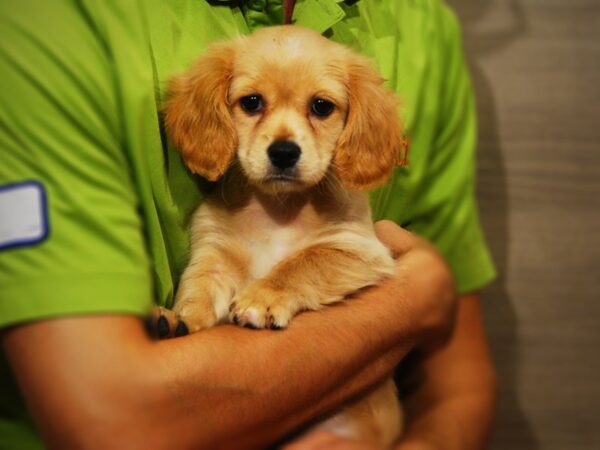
[409,2,496,293]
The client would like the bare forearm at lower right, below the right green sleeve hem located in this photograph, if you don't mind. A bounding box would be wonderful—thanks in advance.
[398,295,495,450]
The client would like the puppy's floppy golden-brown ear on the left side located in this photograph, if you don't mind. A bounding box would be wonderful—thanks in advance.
[165,44,237,181]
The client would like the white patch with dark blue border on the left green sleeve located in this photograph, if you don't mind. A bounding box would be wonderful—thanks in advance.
[0,181,48,249]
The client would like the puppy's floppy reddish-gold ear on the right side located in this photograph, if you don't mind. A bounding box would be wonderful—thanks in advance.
[334,57,405,190]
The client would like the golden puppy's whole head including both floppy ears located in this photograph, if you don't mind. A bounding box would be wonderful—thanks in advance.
[165,26,402,192]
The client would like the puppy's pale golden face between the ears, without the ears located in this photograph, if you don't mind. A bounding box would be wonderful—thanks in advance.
[228,38,348,192]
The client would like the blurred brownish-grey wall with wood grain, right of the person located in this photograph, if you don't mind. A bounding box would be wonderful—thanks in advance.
[447,0,600,450]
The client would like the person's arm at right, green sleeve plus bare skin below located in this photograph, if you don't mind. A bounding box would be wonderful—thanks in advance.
[390,2,495,450]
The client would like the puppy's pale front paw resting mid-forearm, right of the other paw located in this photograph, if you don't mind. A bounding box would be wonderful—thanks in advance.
[229,283,301,330]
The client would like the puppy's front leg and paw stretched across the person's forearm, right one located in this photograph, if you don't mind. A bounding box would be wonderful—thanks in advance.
[231,232,394,328]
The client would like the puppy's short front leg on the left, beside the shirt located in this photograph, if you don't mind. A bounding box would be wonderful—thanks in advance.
[173,245,248,333]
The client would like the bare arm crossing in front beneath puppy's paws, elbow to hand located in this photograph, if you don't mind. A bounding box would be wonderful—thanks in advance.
[3,222,454,449]
